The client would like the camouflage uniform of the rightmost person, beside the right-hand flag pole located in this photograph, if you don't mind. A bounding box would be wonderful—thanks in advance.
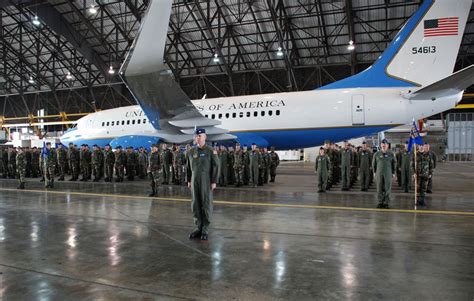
[412,152,433,206]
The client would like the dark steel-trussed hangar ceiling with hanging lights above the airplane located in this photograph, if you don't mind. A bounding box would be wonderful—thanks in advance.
[0,0,474,116]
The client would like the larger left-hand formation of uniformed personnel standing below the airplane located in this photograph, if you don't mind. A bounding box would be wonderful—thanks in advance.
[0,143,280,191]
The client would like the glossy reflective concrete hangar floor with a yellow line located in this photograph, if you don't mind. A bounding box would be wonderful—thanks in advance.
[0,163,474,300]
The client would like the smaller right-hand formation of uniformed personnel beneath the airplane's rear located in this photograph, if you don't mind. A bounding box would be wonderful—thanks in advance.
[315,139,436,208]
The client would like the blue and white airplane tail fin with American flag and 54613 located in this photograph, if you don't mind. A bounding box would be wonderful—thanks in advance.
[321,0,472,89]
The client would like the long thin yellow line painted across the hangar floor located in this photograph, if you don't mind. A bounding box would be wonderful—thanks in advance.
[0,188,474,217]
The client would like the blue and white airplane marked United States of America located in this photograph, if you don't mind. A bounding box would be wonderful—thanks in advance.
[60,0,474,150]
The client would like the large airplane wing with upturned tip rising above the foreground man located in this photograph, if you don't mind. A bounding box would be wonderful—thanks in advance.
[121,0,236,143]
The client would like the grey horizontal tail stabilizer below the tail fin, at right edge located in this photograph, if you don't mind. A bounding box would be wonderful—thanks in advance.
[409,65,474,100]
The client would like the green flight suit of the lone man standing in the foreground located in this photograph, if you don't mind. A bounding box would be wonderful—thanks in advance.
[186,145,219,234]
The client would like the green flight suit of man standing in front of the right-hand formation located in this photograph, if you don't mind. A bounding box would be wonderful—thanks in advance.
[372,146,397,208]
